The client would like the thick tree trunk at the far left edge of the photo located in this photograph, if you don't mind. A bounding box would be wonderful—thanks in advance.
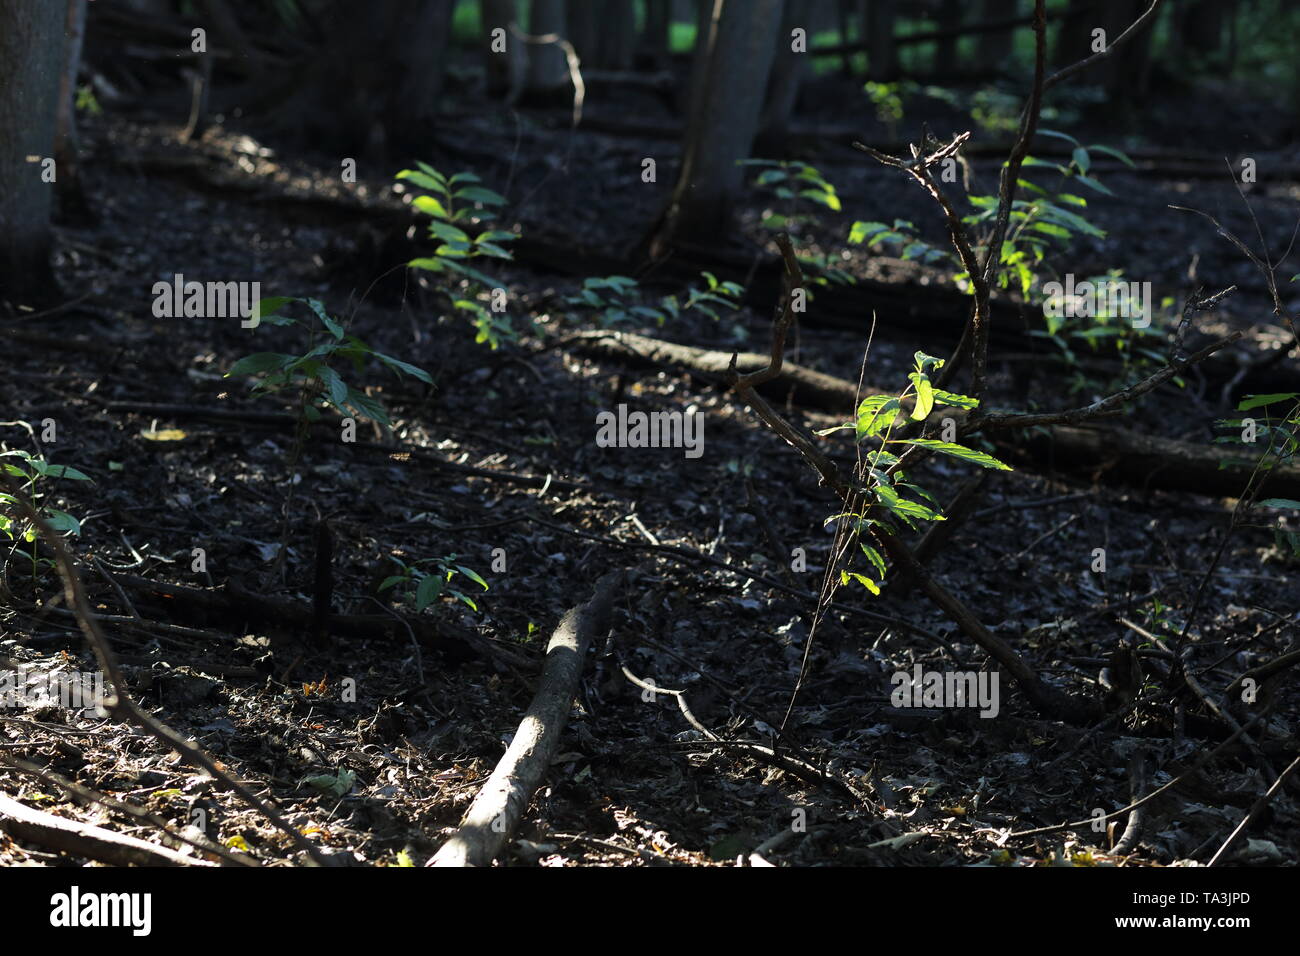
[0,0,68,306]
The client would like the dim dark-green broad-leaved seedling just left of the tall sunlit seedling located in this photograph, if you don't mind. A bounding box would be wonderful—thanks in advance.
[225,297,433,433]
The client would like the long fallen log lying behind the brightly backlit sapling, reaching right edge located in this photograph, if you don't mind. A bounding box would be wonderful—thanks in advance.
[569,330,1300,497]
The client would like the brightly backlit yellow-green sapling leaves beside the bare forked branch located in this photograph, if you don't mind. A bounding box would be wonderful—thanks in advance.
[818,352,1011,594]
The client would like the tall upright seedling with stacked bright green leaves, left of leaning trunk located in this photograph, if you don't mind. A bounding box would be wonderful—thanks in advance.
[397,163,517,349]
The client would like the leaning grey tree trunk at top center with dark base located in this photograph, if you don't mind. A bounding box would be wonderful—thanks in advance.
[651,0,783,255]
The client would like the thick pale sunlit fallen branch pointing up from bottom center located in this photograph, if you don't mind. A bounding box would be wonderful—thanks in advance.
[426,571,623,866]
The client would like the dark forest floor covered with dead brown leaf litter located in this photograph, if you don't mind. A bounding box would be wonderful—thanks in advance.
[0,72,1300,865]
